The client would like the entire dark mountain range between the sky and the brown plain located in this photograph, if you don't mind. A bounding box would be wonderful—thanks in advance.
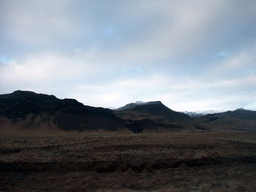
[0,91,256,133]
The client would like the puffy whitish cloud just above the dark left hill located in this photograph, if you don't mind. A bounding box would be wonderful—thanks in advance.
[0,52,100,92]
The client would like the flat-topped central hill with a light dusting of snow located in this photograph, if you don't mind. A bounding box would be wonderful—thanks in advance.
[114,101,192,132]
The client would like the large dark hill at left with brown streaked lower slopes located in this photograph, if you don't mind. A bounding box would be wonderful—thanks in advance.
[0,91,125,131]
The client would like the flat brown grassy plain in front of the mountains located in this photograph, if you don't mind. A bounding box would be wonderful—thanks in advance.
[0,131,256,192]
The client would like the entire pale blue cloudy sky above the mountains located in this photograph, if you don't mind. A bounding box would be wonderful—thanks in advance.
[0,0,256,111]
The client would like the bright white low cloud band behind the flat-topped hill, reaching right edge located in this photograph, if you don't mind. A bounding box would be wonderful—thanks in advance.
[65,68,256,111]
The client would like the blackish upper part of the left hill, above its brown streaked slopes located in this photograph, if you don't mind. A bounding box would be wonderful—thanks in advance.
[0,91,115,118]
